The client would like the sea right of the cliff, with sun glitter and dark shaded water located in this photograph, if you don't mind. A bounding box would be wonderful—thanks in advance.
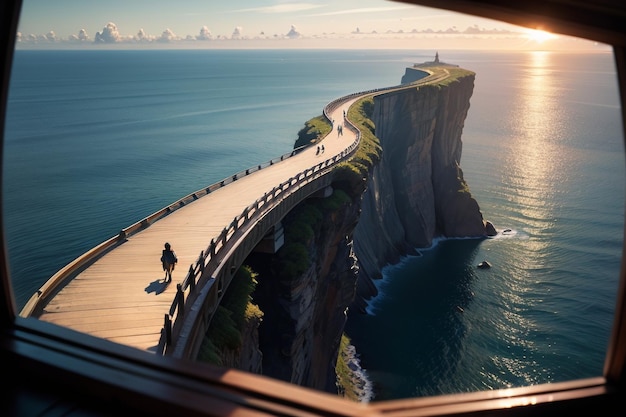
[347,52,624,400]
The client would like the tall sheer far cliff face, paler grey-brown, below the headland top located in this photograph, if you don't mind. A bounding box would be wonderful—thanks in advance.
[354,71,493,309]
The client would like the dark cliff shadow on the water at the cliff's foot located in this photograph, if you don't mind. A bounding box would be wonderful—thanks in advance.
[346,239,480,401]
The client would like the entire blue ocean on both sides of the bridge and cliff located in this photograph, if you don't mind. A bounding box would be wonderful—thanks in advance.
[2,50,625,401]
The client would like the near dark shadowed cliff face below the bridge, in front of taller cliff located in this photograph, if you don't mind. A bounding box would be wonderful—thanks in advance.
[245,193,360,392]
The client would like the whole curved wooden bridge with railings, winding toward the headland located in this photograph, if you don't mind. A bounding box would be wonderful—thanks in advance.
[20,71,447,358]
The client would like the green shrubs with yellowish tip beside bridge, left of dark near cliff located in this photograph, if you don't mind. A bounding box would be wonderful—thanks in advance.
[197,266,263,365]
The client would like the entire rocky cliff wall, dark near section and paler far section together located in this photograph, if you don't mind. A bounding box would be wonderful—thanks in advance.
[232,66,489,392]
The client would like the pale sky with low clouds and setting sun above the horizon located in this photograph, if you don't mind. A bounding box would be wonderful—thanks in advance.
[17,0,603,50]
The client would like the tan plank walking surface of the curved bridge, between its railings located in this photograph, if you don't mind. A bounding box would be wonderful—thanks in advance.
[39,98,356,351]
